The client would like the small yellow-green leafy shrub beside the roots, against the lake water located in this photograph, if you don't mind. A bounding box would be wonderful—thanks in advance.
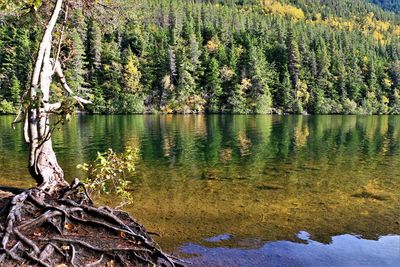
[77,148,139,207]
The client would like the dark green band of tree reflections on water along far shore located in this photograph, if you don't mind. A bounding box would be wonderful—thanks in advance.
[0,115,400,180]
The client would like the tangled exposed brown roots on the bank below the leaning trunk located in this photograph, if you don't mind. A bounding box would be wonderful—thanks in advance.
[0,180,182,267]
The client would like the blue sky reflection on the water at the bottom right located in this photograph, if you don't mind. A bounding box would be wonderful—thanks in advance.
[181,232,400,267]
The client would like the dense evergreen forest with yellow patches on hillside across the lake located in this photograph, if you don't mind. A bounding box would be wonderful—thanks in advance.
[0,0,400,114]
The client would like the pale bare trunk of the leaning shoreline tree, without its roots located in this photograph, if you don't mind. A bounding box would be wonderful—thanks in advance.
[24,0,68,194]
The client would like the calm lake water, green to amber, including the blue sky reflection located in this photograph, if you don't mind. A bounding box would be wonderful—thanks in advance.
[0,115,400,266]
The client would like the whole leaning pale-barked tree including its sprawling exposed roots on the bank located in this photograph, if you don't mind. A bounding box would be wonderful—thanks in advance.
[0,0,182,267]
